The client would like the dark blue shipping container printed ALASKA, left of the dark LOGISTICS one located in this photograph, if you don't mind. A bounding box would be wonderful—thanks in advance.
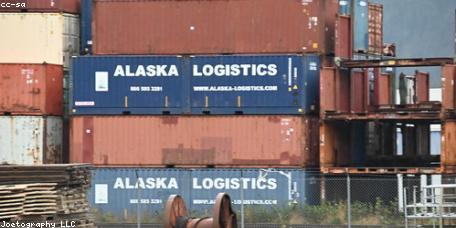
[70,56,185,114]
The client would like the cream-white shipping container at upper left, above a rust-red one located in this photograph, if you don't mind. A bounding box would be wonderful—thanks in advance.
[0,13,79,68]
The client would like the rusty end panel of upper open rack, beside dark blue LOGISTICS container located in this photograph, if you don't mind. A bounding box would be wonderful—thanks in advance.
[320,67,336,114]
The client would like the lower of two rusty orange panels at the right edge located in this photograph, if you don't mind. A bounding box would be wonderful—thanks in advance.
[440,121,456,168]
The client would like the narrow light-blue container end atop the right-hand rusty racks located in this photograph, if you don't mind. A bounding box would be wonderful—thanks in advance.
[352,0,369,53]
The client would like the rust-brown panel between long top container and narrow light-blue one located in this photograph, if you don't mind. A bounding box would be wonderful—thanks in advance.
[335,16,353,59]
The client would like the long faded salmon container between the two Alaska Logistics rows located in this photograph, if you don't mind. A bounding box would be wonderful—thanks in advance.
[70,116,318,167]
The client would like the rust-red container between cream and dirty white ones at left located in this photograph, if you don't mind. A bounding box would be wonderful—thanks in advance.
[0,64,63,115]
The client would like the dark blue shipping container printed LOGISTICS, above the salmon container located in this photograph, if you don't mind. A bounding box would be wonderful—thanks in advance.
[190,55,320,114]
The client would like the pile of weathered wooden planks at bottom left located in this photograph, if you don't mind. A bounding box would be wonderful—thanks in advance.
[0,164,95,227]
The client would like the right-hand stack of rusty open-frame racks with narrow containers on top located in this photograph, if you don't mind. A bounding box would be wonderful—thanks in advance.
[320,0,452,173]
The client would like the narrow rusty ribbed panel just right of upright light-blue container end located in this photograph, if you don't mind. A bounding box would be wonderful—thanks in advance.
[368,3,383,55]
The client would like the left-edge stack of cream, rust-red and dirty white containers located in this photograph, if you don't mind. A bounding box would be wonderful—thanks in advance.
[0,0,79,165]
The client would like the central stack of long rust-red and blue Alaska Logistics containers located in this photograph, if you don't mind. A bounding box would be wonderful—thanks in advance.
[70,0,339,221]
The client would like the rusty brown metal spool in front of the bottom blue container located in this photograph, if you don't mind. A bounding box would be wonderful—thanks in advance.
[164,193,237,228]
